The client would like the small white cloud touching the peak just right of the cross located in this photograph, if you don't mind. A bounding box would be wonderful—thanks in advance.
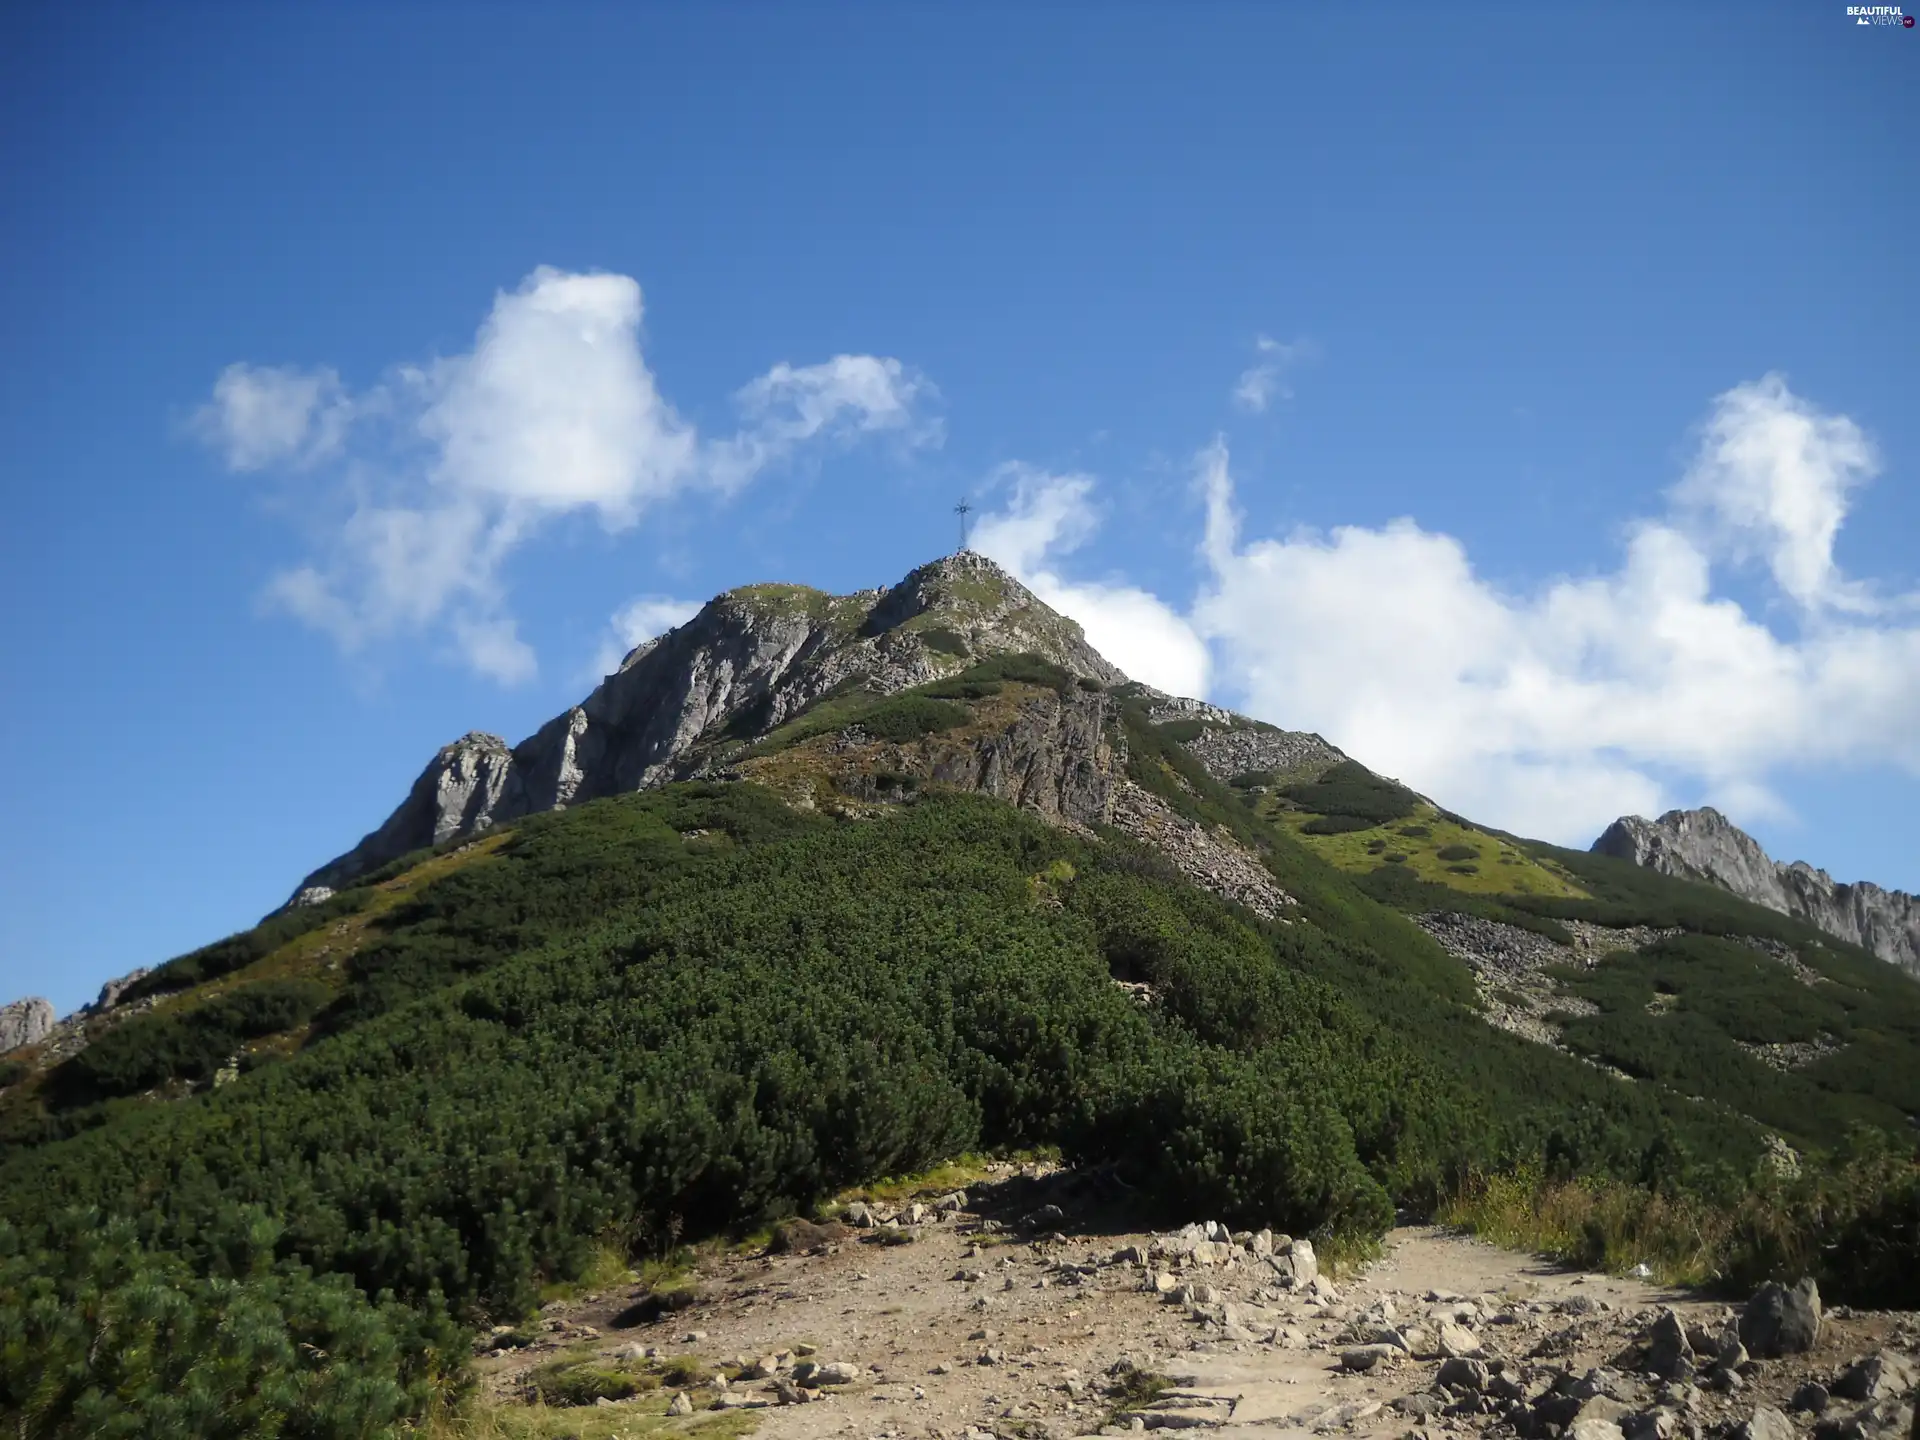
[972,465,1208,695]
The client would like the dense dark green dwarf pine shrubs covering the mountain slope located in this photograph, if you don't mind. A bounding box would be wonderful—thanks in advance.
[0,683,1920,1436]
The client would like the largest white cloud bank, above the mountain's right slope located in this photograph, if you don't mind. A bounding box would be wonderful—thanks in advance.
[1188,376,1920,843]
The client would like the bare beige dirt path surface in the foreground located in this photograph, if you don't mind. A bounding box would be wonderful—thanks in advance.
[480,1175,1920,1440]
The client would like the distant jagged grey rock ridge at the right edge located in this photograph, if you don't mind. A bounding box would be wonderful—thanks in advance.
[1594,808,1920,979]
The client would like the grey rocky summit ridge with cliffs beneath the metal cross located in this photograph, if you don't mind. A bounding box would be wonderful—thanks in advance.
[296,553,1125,895]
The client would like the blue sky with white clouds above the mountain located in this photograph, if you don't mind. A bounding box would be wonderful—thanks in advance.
[0,4,1920,1010]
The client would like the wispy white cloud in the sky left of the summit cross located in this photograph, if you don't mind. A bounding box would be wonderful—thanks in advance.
[194,267,939,684]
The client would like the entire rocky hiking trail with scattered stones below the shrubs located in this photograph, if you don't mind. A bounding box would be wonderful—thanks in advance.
[476,1165,1920,1440]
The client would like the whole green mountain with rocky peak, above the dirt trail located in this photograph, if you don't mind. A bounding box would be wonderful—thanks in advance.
[0,555,1920,1434]
